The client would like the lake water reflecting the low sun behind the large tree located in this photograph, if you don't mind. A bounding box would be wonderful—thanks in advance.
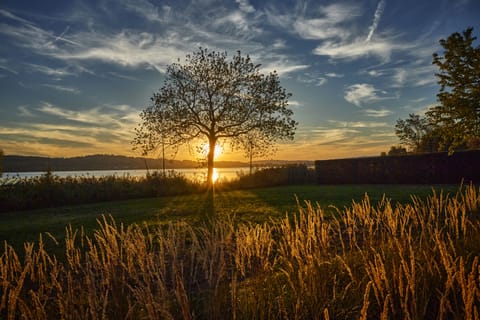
[2,167,249,182]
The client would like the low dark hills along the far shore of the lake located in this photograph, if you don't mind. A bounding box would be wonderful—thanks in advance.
[1,155,314,173]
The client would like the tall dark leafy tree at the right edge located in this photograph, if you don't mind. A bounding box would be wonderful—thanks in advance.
[427,28,480,152]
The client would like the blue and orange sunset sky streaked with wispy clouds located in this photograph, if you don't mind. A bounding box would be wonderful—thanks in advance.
[0,0,480,160]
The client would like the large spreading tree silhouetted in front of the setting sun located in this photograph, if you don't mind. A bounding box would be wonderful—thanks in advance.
[134,48,297,187]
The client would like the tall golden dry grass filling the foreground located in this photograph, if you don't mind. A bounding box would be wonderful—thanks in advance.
[0,185,480,320]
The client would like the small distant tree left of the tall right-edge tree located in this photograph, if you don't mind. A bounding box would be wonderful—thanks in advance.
[395,113,429,152]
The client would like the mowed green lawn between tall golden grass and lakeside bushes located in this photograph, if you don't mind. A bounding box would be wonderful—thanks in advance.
[0,185,459,251]
